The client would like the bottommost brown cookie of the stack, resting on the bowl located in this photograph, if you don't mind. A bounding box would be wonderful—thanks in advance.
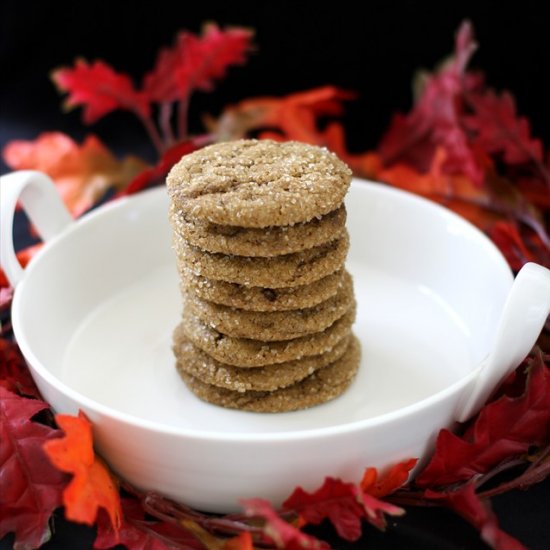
[181,336,360,413]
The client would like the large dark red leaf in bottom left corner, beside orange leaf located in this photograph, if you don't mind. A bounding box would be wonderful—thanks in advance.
[0,386,68,549]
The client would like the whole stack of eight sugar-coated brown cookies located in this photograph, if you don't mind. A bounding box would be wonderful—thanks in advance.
[167,140,359,412]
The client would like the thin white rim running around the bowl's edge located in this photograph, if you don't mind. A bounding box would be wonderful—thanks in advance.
[12,178,513,443]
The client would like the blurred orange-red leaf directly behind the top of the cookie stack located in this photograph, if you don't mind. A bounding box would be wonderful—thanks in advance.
[211,86,355,145]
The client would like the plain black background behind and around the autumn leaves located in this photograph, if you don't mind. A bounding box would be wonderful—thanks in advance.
[0,0,550,550]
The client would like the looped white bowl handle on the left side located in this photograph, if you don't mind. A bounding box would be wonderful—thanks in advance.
[0,170,73,287]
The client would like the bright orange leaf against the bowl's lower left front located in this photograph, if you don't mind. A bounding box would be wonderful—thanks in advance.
[44,412,122,530]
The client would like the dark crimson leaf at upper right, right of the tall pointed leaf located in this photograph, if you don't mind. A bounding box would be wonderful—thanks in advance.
[464,90,543,164]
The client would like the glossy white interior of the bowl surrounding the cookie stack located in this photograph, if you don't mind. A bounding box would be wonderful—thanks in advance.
[13,181,512,434]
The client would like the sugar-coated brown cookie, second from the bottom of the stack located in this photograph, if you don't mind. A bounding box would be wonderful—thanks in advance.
[176,338,349,393]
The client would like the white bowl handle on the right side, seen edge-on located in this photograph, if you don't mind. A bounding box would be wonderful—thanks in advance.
[457,263,550,422]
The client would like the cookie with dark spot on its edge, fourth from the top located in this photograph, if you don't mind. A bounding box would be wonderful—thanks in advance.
[181,269,346,311]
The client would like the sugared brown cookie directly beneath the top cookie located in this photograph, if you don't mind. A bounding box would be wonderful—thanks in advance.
[170,205,346,257]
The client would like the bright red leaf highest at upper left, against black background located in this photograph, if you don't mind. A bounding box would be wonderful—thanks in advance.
[144,23,252,103]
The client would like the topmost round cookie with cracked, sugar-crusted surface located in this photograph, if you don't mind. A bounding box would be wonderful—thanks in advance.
[166,140,351,231]
